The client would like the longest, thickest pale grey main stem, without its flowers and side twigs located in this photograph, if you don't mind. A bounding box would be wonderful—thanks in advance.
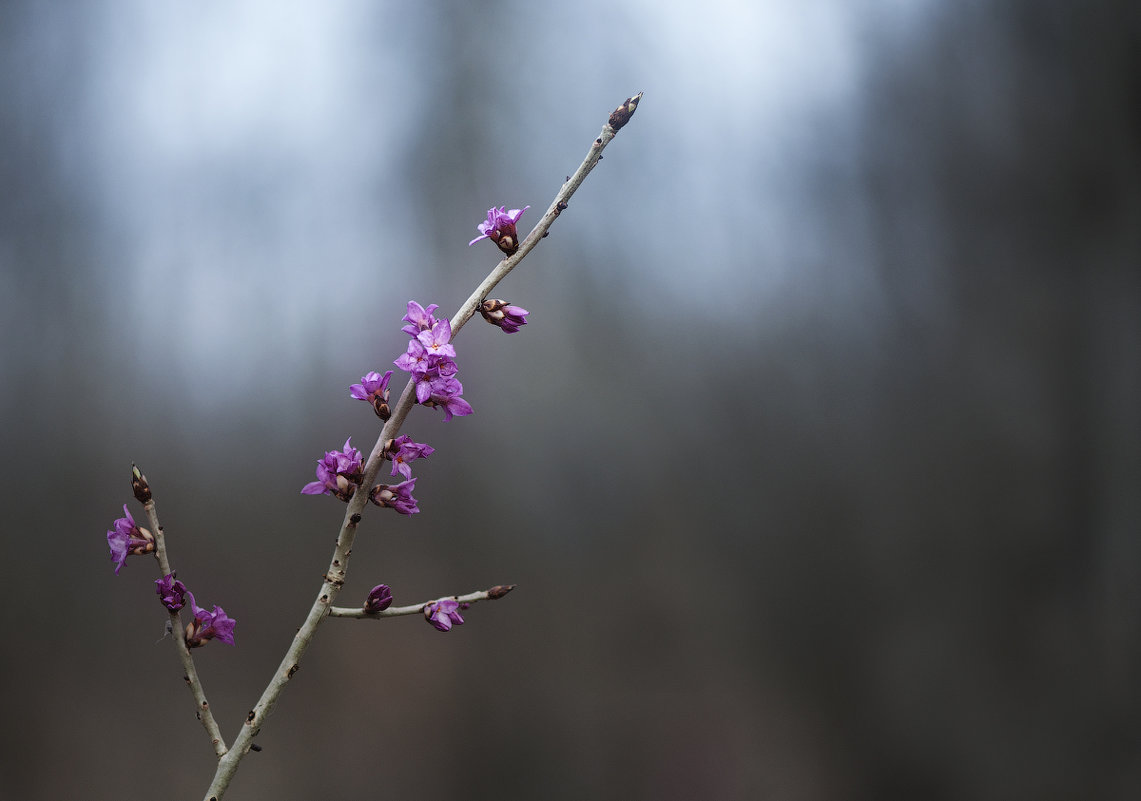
[205,94,641,801]
